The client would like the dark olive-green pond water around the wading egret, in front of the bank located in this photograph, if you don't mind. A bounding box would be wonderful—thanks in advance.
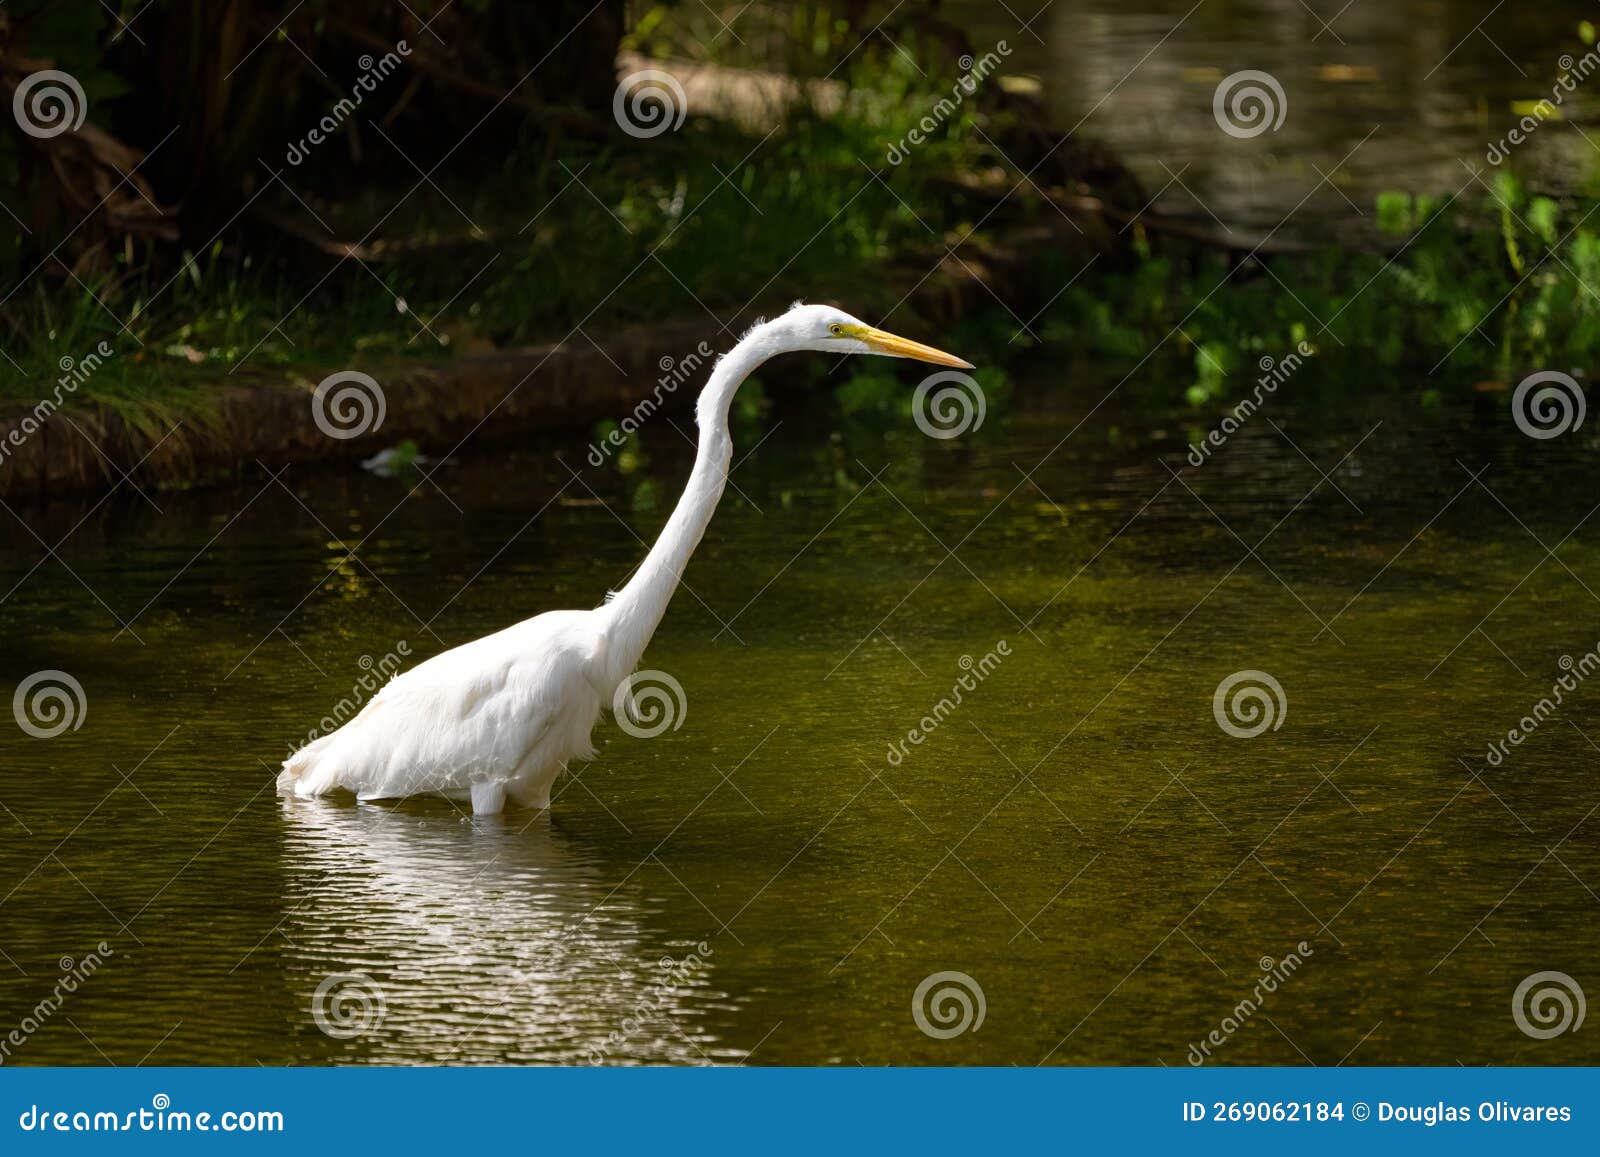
[0,368,1600,1066]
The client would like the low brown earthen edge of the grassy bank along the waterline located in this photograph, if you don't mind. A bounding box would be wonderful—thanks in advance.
[0,219,1106,498]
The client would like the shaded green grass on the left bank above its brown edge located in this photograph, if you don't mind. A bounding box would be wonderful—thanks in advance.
[0,5,1011,403]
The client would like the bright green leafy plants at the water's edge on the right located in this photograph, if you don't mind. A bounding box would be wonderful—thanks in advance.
[1045,171,1600,405]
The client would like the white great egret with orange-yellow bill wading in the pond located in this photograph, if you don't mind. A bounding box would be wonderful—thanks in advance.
[278,304,973,815]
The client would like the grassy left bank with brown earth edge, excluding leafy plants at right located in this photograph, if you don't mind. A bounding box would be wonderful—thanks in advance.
[0,29,1138,496]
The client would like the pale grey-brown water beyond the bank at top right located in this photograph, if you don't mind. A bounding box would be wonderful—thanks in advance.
[949,0,1600,238]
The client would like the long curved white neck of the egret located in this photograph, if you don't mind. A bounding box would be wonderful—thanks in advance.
[600,326,779,687]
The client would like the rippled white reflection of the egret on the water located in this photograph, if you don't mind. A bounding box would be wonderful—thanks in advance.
[283,799,744,1064]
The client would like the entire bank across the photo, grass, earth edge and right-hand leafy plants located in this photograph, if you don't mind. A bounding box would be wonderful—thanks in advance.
[0,37,1600,496]
